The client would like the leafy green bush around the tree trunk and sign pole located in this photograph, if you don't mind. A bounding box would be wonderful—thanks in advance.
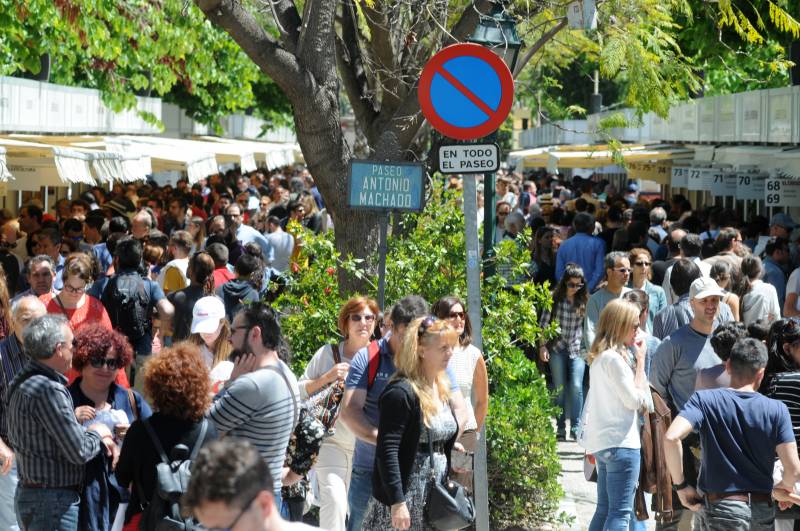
[275,186,562,528]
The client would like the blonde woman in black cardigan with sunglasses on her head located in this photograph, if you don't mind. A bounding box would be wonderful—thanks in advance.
[362,316,458,530]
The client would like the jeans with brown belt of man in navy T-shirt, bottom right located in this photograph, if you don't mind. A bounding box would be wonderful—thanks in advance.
[696,500,775,531]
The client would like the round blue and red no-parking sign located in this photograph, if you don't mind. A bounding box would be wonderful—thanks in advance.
[417,43,514,140]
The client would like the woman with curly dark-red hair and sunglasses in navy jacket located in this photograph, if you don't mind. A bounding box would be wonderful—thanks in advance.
[64,324,152,531]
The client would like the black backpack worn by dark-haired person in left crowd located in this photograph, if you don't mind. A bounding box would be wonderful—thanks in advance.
[102,273,150,343]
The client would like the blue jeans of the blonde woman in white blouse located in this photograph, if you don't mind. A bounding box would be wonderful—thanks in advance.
[589,448,641,531]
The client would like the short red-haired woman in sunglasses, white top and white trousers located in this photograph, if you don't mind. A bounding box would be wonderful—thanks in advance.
[298,297,380,531]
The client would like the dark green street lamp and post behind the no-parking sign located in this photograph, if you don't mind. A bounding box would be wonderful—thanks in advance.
[468,0,522,270]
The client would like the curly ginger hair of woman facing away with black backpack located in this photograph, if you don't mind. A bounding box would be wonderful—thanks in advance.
[144,341,211,422]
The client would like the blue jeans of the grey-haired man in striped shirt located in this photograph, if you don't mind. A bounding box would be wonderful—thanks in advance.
[14,485,81,531]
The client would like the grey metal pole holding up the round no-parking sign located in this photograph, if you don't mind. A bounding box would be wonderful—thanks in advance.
[464,174,489,531]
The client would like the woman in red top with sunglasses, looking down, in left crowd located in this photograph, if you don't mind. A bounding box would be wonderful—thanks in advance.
[39,253,129,388]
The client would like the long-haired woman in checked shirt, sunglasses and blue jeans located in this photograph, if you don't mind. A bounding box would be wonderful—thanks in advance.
[539,262,589,441]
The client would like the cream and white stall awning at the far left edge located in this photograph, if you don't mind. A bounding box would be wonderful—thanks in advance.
[0,138,96,191]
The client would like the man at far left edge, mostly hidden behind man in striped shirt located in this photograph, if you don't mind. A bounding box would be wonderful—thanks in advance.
[0,295,47,531]
